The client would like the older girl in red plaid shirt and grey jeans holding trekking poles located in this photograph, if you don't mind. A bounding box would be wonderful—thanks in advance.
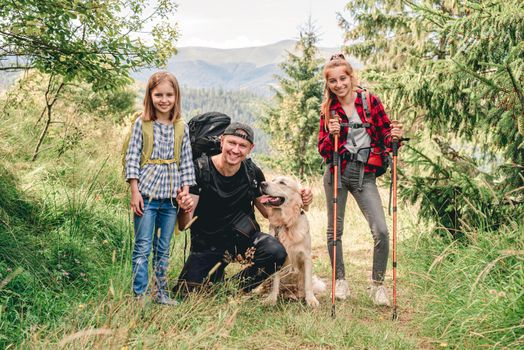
[318,54,402,305]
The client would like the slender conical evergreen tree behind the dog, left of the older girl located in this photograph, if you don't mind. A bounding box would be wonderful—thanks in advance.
[261,21,323,178]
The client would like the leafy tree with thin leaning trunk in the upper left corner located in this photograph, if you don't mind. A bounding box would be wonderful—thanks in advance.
[0,0,177,159]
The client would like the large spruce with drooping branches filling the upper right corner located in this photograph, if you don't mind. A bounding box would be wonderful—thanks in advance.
[339,0,524,236]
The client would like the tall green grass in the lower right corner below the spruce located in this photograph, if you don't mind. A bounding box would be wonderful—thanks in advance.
[406,223,524,349]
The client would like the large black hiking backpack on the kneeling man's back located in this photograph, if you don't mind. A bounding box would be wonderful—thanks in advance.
[187,112,231,160]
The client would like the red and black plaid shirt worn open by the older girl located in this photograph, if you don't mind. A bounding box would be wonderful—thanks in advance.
[318,90,391,173]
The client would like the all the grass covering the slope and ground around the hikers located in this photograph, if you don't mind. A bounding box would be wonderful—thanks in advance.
[0,72,524,349]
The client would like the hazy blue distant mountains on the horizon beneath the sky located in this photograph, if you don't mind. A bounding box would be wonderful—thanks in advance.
[133,40,362,96]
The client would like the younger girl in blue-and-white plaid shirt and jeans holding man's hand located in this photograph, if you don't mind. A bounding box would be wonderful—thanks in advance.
[125,72,196,305]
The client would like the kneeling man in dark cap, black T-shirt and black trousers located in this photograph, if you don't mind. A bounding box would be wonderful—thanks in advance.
[175,122,313,293]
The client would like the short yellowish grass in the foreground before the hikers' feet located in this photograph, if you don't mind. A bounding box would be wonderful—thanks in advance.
[17,256,418,349]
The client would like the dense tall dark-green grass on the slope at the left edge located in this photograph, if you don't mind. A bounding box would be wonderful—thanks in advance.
[0,159,133,347]
